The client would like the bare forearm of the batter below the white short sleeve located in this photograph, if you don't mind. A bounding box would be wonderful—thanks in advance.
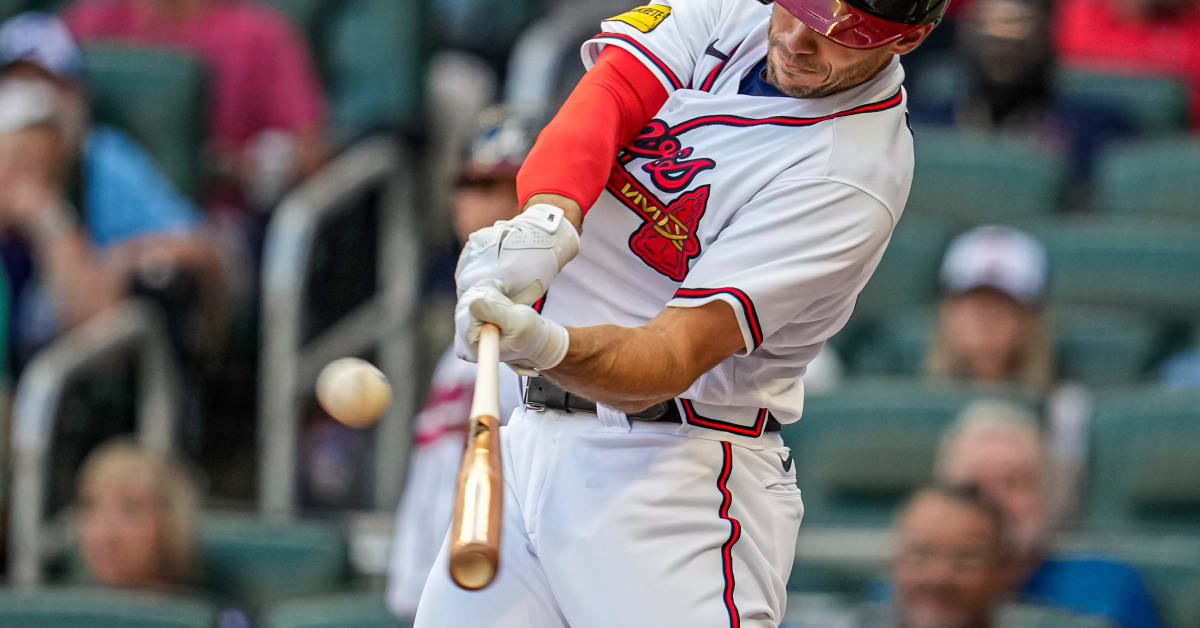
[542,325,695,412]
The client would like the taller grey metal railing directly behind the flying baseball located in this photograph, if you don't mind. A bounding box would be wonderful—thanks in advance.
[258,138,420,519]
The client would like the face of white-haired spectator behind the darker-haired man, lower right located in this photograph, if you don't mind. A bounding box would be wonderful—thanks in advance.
[944,430,1046,554]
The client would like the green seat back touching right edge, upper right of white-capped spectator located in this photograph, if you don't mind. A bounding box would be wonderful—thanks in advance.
[1094,137,1200,220]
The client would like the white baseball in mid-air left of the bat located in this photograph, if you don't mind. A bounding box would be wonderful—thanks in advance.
[317,358,391,427]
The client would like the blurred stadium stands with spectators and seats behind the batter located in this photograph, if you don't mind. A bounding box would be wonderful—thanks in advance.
[0,0,1200,628]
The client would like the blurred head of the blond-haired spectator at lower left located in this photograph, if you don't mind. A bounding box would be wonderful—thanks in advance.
[79,438,198,590]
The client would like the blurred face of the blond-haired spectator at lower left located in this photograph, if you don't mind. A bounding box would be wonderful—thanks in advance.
[79,476,166,587]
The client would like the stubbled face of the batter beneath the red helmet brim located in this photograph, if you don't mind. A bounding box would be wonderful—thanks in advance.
[767,5,929,98]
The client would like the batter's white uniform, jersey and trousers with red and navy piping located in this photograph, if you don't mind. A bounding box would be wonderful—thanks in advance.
[415,0,912,628]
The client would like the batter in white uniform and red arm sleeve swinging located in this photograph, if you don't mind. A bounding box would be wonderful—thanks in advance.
[416,0,948,628]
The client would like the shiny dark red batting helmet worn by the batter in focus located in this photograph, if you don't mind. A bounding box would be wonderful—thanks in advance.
[775,0,950,49]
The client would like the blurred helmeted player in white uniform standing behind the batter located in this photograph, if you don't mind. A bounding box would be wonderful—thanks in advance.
[388,107,536,617]
